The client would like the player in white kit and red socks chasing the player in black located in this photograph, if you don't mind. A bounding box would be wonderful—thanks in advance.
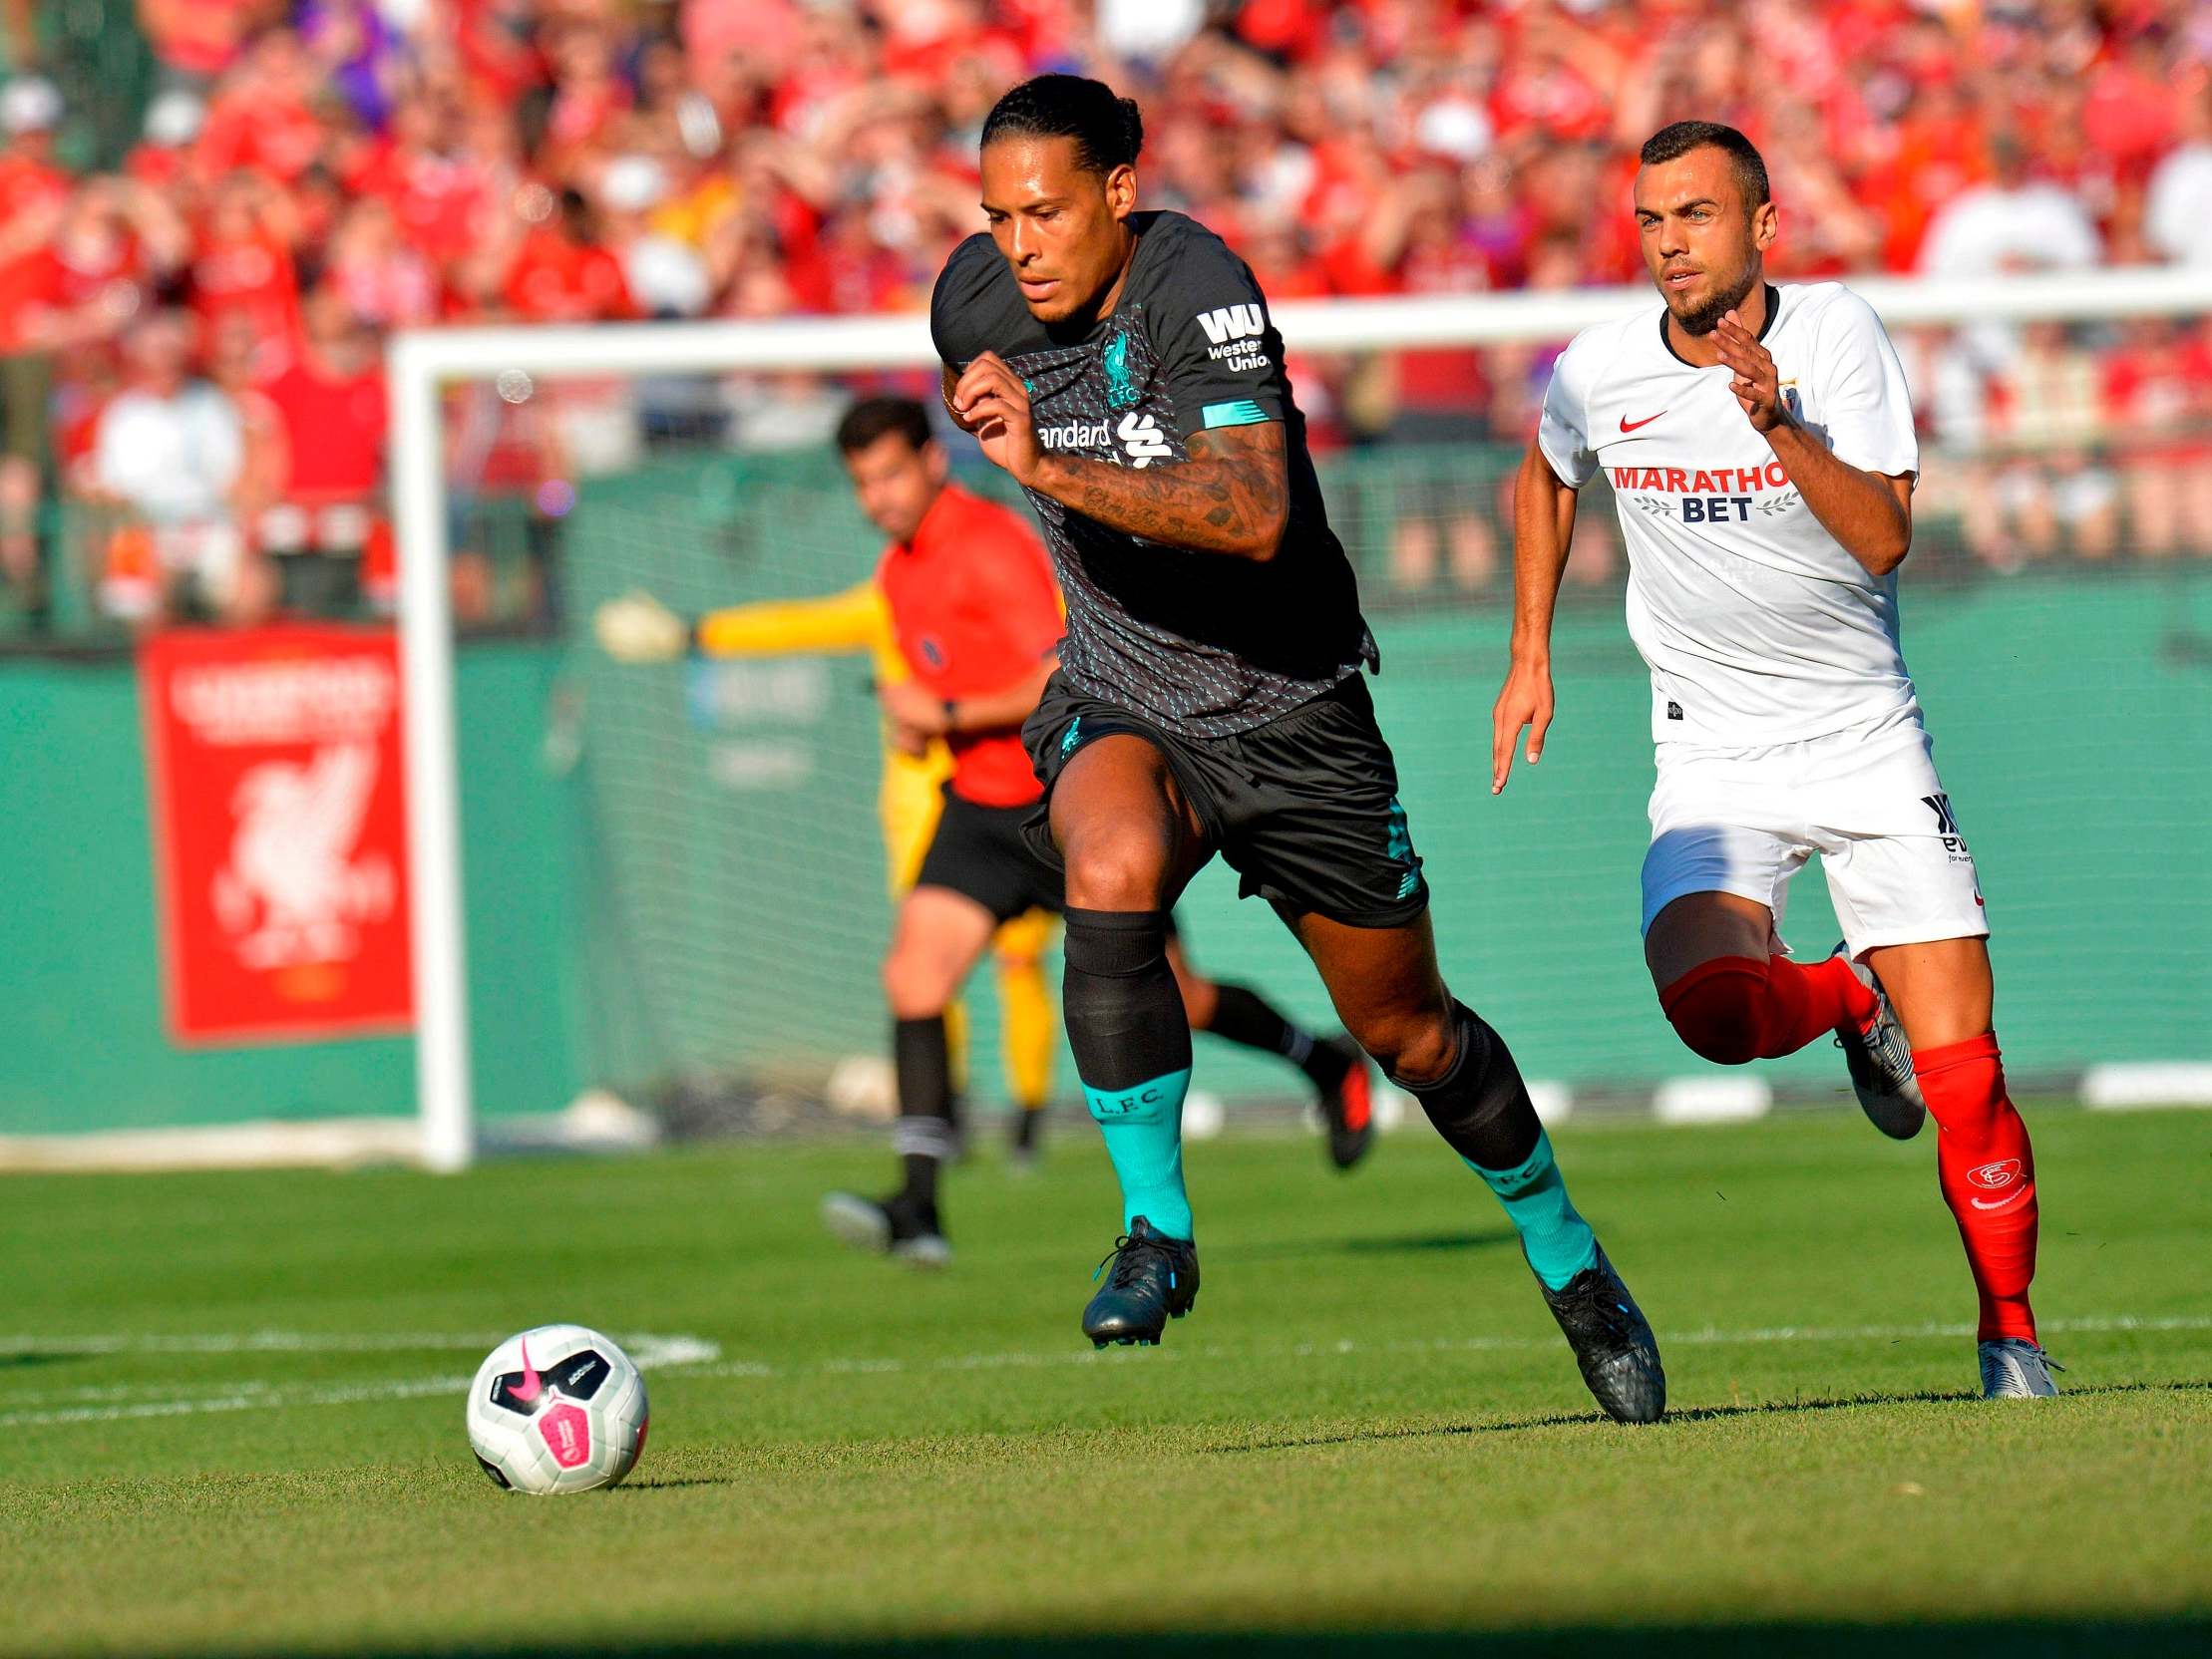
[1491,122,2057,1396]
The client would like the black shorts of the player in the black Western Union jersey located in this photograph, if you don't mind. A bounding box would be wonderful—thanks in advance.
[1022,675,1429,927]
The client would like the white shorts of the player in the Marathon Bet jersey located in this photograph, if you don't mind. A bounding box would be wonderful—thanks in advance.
[1644,708,1989,958]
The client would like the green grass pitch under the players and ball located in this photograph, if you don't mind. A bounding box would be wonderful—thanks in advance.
[0,1106,2212,1659]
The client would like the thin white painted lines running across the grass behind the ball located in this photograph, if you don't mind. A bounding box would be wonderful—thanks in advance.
[0,1314,2212,1429]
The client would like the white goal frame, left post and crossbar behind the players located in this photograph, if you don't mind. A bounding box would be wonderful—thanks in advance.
[387,267,2212,1170]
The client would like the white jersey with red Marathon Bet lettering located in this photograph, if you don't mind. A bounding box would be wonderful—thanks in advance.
[1538,283,1920,748]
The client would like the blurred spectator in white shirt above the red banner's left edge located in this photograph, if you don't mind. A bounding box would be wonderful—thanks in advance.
[91,312,259,621]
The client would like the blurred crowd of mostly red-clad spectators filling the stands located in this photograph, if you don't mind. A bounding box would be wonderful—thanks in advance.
[0,0,2212,617]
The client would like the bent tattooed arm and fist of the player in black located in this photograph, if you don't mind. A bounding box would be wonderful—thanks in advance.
[946,352,1290,562]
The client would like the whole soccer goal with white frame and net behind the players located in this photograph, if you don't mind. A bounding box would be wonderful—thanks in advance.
[394,272,2212,1165]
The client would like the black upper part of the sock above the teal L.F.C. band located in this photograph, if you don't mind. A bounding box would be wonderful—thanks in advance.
[1059,909,1190,1091]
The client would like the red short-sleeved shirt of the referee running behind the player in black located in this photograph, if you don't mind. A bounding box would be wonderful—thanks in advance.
[876,485,1062,808]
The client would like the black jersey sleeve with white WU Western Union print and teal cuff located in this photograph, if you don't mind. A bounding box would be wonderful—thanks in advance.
[1146,228,1286,438]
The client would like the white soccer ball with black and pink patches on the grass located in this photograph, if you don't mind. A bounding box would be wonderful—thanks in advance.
[469,1325,646,1493]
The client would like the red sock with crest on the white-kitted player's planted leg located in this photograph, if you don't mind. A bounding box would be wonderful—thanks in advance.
[1914,1033,2035,1343]
